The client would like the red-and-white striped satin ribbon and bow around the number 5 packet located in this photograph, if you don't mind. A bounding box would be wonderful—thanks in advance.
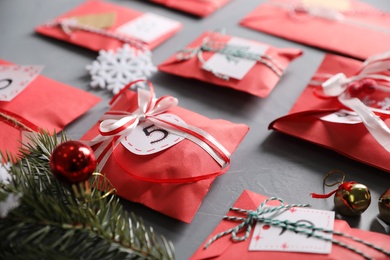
[87,80,230,183]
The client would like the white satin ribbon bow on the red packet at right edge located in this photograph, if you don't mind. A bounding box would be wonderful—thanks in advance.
[311,52,390,152]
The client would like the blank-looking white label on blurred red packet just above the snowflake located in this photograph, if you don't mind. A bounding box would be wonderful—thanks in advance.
[116,13,180,43]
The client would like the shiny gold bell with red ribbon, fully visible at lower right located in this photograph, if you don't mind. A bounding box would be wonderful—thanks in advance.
[334,182,372,216]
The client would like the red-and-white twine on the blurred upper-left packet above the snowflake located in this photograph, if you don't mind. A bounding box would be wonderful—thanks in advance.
[45,18,148,51]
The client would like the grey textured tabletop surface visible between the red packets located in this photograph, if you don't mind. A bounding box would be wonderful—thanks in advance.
[0,0,390,259]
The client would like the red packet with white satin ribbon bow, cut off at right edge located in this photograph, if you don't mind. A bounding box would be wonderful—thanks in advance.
[269,52,390,171]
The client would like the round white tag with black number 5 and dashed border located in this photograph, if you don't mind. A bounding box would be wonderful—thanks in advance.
[122,114,186,155]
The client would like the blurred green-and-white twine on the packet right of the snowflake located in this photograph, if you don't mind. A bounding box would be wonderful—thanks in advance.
[176,32,285,80]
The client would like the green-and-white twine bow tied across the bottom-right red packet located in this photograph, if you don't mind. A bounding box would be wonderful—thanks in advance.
[204,197,390,259]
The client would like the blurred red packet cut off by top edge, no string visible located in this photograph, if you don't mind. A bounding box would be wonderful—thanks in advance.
[151,0,230,17]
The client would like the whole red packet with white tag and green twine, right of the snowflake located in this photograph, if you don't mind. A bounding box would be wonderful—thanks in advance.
[158,32,302,97]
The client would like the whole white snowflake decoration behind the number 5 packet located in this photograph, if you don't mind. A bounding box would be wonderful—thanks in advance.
[86,44,157,94]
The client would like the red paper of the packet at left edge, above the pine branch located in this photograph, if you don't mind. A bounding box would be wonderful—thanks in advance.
[0,60,100,158]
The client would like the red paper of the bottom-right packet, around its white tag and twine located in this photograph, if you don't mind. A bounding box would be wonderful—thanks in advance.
[190,190,390,260]
